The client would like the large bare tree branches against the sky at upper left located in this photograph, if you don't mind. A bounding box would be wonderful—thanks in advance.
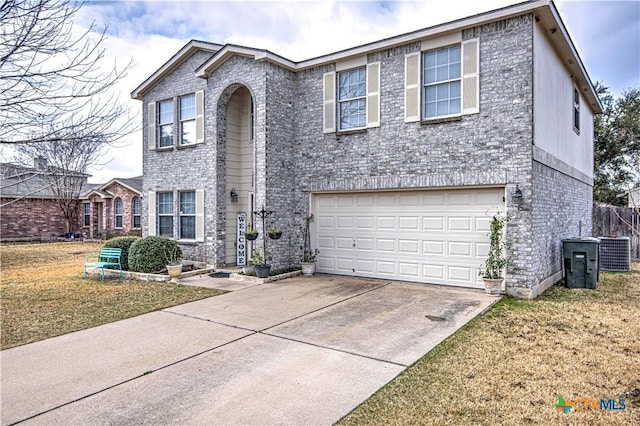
[0,0,135,144]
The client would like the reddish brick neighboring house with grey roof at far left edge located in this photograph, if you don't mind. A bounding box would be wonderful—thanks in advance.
[0,163,89,241]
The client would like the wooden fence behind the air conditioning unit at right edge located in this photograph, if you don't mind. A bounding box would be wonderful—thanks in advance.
[593,204,640,259]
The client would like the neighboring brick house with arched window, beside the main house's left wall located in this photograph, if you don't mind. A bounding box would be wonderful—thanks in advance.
[80,176,142,239]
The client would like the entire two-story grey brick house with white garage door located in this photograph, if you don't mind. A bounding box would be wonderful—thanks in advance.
[132,0,601,298]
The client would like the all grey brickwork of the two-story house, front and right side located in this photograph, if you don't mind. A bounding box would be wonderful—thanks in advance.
[136,8,592,297]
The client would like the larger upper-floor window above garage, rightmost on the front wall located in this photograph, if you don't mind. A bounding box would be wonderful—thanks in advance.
[422,45,462,119]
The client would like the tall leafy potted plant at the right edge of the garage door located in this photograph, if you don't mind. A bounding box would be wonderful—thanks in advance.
[480,215,509,296]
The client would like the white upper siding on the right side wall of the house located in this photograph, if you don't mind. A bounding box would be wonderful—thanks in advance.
[533,20,593,177]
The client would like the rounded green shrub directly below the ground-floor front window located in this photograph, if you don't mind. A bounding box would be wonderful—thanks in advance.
[129,236,182,273]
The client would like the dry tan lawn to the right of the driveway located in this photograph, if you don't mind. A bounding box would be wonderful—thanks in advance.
[340,263,640,425]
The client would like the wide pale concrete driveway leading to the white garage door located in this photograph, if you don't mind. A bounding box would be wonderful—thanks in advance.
[0,275,496,425]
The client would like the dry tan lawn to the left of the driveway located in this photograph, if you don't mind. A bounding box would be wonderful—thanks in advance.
[0,243,222,349]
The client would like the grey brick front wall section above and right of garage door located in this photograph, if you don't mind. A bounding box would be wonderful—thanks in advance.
[292,15,536,287]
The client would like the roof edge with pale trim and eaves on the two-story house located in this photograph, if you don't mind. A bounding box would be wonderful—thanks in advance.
[131,0,602,113]
